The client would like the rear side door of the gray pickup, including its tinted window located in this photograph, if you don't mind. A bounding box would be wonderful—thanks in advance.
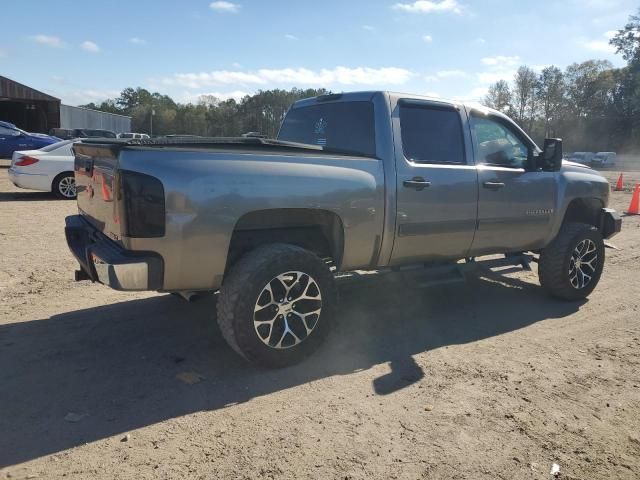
[391,99,478,265]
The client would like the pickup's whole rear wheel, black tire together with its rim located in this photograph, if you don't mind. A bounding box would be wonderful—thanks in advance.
[218,244,336,367]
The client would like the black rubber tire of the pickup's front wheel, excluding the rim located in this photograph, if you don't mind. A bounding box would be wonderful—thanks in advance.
[538,223,605,300]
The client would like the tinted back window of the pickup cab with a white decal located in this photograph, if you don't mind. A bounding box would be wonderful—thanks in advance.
[278,102,376,156]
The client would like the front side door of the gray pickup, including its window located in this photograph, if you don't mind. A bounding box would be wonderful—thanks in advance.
[469,111,557,255]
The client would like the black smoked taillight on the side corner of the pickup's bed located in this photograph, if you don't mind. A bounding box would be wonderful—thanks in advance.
[119,170,165,238]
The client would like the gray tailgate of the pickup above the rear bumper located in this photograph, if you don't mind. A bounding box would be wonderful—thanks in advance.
[73,143,121,241]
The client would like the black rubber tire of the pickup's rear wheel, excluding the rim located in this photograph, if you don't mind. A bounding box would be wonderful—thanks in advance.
[217,244,337,368]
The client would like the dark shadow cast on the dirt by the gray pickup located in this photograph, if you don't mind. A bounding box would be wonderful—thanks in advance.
[0,276,581,467]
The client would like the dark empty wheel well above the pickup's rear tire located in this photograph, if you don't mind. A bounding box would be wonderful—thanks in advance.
[226,208,344,269]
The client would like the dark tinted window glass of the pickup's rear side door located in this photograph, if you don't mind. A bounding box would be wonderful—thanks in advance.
[400,104,466,164]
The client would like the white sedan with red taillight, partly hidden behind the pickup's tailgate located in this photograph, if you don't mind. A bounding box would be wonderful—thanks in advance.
[9,140,76,199]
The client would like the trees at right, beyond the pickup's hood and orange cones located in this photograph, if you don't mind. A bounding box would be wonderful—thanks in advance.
[482,10,640,153]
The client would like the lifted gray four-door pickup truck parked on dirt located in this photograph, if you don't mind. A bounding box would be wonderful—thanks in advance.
[66,92,621,366]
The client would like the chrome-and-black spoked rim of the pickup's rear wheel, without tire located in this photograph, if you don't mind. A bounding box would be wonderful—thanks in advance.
[253,271,322,349]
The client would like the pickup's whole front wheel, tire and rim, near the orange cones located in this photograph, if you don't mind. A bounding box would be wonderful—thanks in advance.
[538,223,604,300]
